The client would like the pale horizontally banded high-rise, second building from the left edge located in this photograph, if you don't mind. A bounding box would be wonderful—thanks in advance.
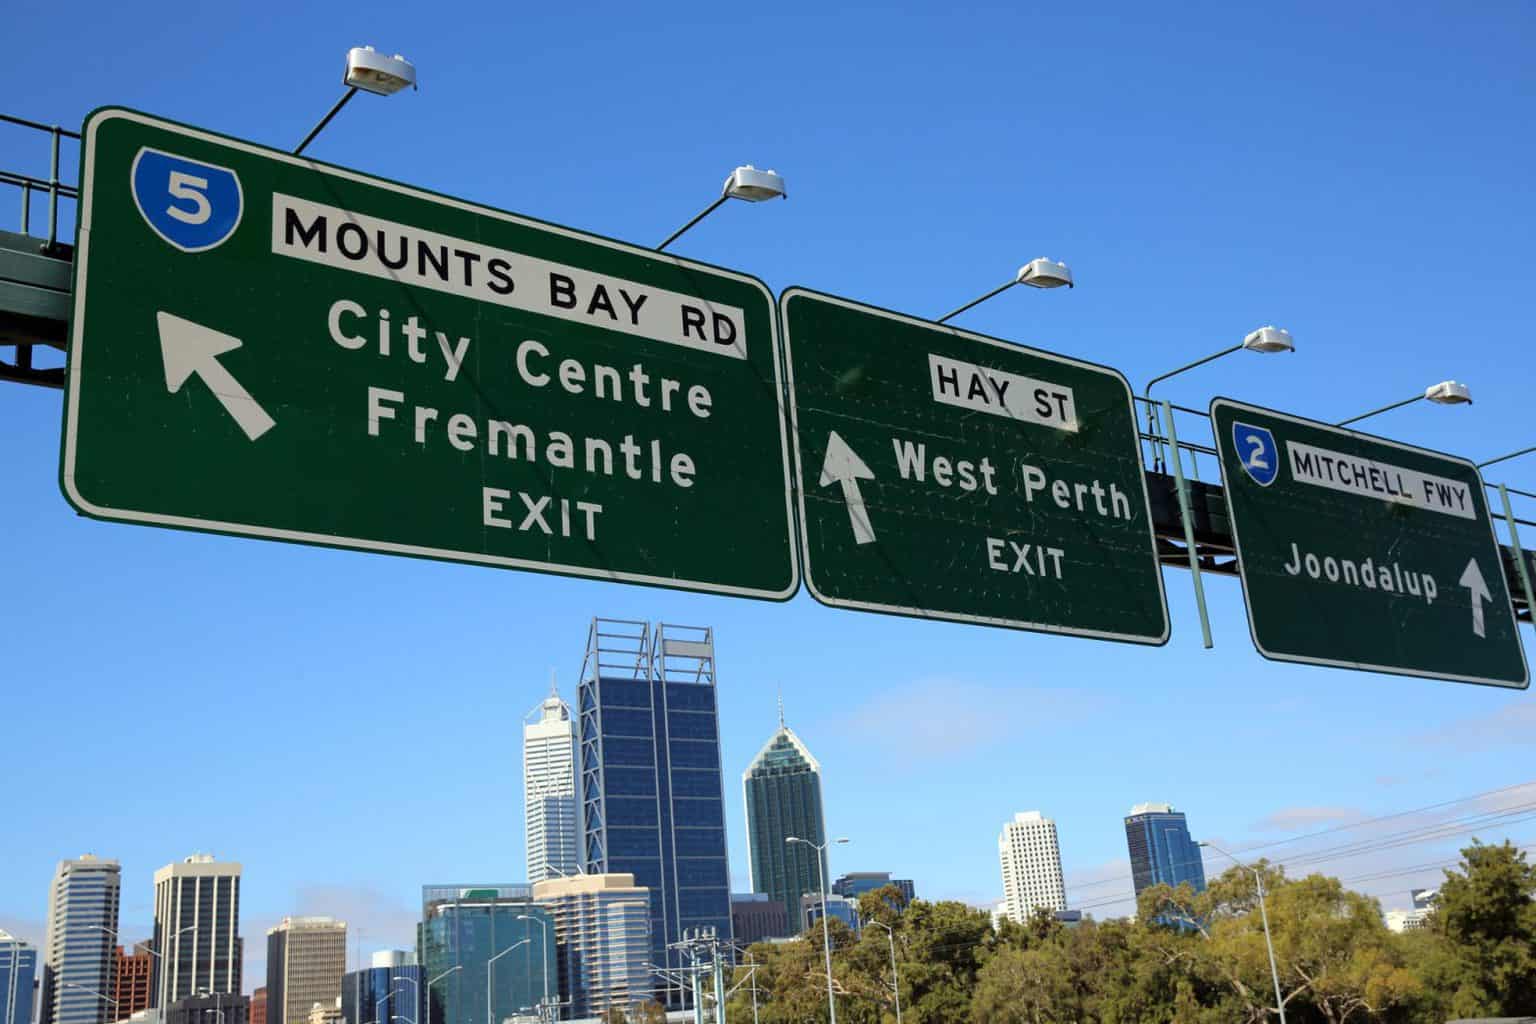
[37,854,123,1024]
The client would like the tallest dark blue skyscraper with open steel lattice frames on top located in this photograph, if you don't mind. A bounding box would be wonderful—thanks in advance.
[578,619,731,1007]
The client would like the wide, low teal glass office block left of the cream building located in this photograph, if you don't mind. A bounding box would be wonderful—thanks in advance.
[420,886,559,1024]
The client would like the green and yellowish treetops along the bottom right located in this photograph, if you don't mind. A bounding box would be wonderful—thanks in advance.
[730,844,1536,1024]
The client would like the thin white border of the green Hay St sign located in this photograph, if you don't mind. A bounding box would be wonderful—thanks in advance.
[779,287,1172,646]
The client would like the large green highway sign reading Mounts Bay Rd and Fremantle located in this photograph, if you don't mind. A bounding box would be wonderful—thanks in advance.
[61,109,799,600]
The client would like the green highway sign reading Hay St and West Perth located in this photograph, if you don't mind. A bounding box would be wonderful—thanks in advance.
[779,289,1169,643]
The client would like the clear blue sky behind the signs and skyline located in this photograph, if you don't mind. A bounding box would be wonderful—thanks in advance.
[0,3,1536,987]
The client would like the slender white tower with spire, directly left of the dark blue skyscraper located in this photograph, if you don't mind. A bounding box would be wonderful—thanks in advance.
[522,683,581,881]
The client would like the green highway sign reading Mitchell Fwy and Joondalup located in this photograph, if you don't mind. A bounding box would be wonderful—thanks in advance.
[1210,398,1528,688]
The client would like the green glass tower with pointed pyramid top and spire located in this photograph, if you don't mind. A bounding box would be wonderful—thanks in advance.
[742,705,831,932]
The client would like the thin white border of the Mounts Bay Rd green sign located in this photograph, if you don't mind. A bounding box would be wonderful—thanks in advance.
[58,107,800,602]
